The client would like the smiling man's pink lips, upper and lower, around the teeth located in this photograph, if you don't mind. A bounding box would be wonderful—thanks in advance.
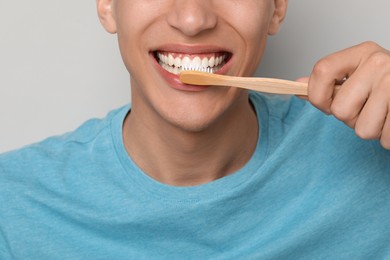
[149,44,233,92]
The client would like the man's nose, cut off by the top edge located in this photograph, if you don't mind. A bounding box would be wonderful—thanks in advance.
[167,0,218,36]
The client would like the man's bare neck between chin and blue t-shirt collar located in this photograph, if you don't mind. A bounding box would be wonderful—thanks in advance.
[123,93,258,186]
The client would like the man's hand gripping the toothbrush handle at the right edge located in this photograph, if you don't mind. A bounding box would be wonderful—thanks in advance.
[308,42,390,149]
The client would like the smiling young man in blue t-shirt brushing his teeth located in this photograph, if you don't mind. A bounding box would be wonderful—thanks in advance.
[0,0,390,259]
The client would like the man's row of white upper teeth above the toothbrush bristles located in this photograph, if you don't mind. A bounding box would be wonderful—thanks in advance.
[157,52,226,74]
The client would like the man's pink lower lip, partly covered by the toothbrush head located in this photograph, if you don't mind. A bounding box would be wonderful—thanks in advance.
[150,53,230,92]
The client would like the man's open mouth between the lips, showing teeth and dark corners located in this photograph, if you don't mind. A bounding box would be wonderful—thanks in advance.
[153,51,232,75]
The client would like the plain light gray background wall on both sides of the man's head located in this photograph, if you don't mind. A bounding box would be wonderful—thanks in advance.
[0,0,390,152]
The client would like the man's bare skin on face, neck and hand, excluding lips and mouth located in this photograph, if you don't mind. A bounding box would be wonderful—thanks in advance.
[97,0,390,186]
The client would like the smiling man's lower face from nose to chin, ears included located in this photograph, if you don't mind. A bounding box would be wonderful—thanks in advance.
[97,0,287,131]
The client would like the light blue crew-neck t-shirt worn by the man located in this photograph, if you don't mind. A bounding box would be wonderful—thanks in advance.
[0,93,390,260]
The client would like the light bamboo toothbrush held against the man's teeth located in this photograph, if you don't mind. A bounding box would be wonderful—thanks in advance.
[180,70,339,96]
